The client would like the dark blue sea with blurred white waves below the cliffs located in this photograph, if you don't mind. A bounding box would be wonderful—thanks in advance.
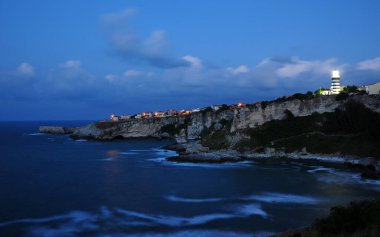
[0,121,380,237]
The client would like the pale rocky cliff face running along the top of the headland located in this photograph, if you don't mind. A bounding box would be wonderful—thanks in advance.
[73,95,380,143]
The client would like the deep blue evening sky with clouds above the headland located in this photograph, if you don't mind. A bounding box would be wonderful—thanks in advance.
[0,0,380,121]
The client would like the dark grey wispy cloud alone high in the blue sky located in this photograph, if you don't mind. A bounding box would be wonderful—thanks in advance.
[102,9,190,68]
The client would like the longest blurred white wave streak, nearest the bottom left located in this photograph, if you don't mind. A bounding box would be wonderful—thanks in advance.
[0,204,268,237]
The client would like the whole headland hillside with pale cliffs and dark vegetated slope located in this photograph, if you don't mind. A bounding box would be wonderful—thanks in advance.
[72,94,380,158]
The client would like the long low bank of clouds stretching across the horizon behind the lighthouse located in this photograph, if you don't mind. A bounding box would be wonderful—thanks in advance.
[0,55,380,119]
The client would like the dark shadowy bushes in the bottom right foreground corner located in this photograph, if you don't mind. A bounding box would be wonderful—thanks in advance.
[278,199,380,237]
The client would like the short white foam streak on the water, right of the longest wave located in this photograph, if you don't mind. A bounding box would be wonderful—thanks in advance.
[243,193,320,205]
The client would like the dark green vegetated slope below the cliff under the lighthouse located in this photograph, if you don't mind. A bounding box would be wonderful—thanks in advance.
[235,101,380,159]
